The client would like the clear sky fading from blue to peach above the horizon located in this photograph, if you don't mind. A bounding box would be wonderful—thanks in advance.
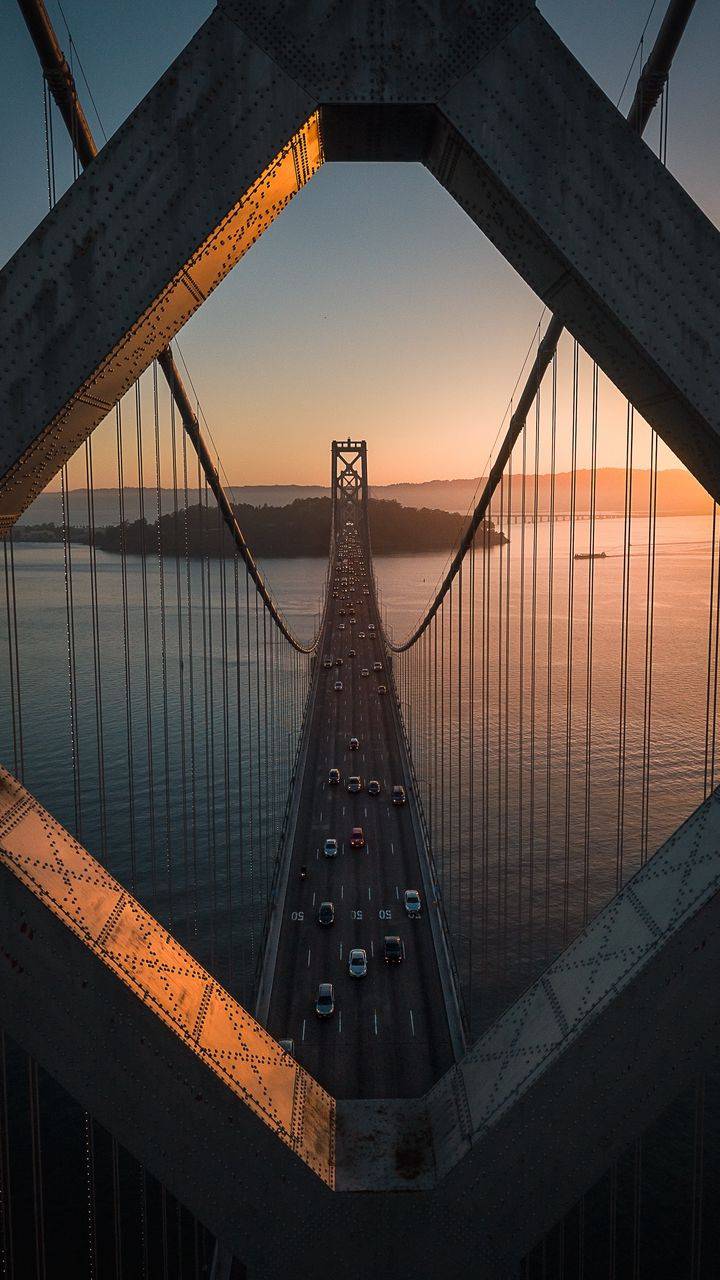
[0,0,720,484]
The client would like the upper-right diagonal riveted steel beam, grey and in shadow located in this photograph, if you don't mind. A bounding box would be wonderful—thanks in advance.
[427,13,720,498]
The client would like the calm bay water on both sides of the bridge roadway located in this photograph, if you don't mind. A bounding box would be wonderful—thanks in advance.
[0,517,720,1276]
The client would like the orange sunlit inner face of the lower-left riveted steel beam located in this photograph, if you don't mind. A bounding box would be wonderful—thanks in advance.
[0,768,336,1188]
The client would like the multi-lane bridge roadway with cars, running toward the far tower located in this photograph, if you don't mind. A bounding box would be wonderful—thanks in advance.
[268,524,452,1097]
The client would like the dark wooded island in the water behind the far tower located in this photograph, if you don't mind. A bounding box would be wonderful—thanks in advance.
[12,497,506,557]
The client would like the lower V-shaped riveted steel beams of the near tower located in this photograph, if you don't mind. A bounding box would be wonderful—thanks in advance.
[0,772,720,1280]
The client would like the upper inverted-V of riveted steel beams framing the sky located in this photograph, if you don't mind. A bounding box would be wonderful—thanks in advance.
[0,0,720,531]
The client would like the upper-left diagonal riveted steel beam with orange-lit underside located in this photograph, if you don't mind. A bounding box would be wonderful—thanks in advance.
[0,10,322,532]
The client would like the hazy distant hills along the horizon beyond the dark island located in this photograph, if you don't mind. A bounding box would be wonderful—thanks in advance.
[19,467,712,529]
